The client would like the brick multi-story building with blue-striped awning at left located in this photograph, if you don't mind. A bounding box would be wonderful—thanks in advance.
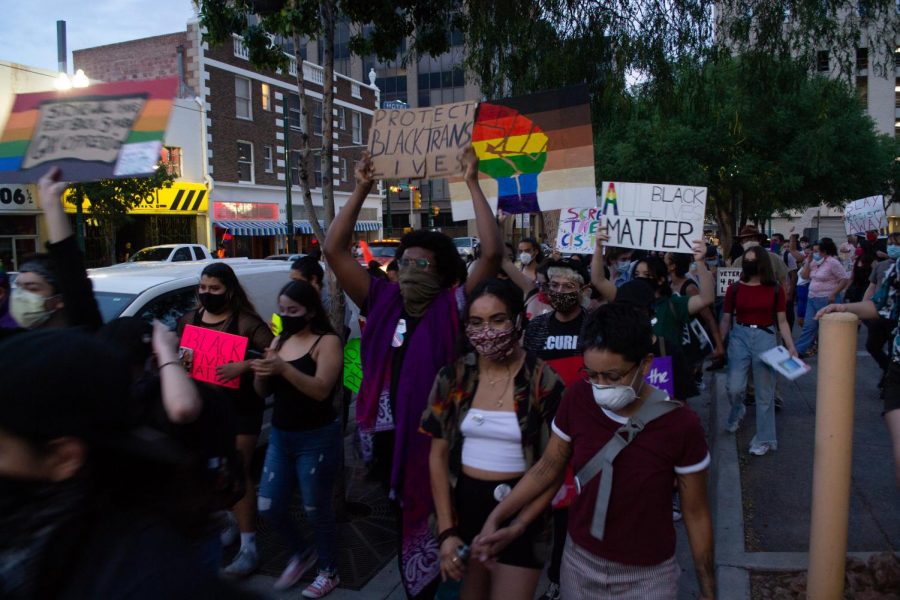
[73,20,381,257]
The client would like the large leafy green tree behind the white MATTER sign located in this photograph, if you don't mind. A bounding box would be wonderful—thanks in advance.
[595,55,898,253]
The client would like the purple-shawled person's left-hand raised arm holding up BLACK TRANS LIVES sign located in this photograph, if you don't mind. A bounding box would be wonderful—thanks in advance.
[323,152,375,307]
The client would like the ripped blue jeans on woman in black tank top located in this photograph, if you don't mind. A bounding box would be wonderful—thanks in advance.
[258,421,341,571]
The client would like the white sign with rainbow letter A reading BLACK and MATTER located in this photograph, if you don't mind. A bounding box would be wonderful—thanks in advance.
[600,181,706,252]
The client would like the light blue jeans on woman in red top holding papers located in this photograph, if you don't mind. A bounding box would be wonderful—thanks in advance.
[726,323,778,449]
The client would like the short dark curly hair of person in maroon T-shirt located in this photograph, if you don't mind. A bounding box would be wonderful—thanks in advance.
[579,302,653,363]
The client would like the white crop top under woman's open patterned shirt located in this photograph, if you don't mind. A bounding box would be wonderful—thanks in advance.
[459,408,526,473]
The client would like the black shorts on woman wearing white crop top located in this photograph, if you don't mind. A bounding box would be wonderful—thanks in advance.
[456,473,546,569]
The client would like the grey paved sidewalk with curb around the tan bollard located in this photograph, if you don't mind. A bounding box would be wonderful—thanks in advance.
[710,327,900,599]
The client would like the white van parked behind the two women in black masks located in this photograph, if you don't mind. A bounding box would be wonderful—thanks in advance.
[88,258,291,329]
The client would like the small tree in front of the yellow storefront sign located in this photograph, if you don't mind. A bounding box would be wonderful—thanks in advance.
[66,163,173,265]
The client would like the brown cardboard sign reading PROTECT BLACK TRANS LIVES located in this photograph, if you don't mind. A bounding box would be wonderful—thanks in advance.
[368,102,477,179]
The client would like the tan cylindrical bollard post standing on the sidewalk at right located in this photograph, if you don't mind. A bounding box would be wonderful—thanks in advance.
[807,313,859,600]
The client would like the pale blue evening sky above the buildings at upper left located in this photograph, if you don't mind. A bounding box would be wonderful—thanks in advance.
[0,0,194,73]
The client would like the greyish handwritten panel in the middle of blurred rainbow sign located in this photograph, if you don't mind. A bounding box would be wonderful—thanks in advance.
[22,95,147,169]
